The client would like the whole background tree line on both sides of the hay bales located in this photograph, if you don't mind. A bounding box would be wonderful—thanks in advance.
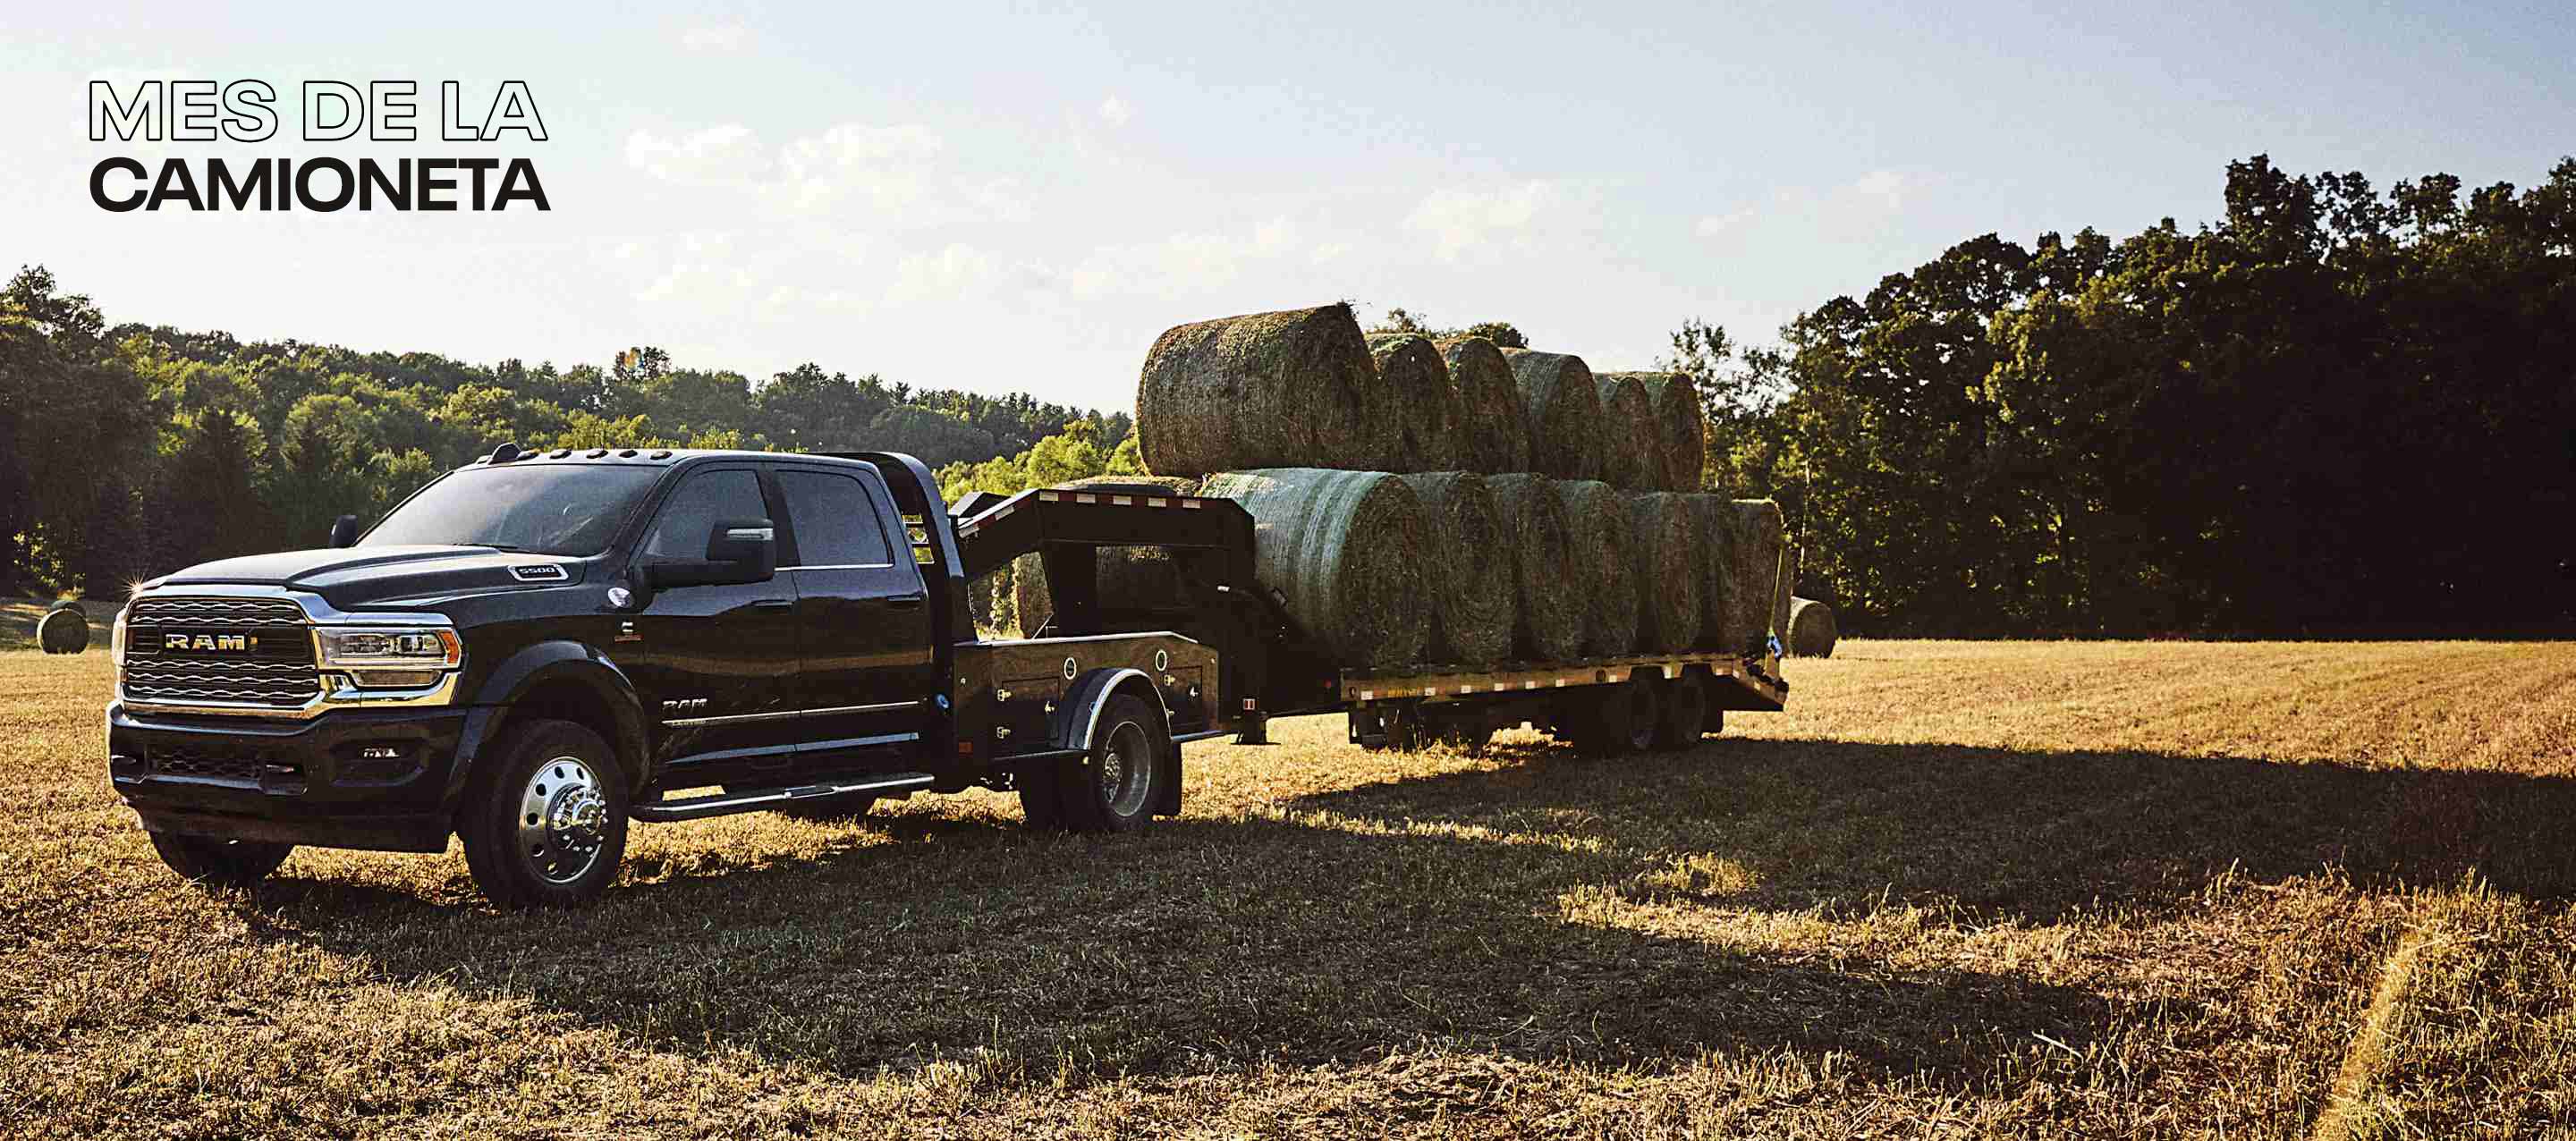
[0,157,2576,636]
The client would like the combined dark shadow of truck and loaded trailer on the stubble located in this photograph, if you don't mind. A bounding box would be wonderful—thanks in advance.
[236,742,2576,1085]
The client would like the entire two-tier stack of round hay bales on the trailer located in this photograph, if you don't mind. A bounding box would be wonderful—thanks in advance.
[1015,304,1788,670]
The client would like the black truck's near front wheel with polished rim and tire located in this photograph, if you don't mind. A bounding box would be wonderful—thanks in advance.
[456,722,629,909]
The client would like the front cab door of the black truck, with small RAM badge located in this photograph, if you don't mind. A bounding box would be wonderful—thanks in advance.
[611,463,799,788]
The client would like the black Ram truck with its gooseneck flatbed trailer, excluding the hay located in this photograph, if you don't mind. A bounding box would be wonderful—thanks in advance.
[106,445,1785,907]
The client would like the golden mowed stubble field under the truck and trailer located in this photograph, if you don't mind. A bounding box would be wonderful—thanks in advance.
[0,641,2576,1138]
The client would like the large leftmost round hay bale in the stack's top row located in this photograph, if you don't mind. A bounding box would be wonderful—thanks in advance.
[1136,304,1402,477]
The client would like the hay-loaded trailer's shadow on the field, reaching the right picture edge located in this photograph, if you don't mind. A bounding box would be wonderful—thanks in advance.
[1296,740,2576,922]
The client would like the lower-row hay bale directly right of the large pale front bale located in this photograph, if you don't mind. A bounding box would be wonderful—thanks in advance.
[1404,471,1517,670]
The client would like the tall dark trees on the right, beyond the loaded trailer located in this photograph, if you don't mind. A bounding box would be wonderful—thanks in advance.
[1669,157,2576,634]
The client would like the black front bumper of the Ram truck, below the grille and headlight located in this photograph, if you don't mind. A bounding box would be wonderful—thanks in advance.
[108,703,492,852]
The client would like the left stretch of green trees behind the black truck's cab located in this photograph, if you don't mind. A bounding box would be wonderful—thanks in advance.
[0,268,1131,597]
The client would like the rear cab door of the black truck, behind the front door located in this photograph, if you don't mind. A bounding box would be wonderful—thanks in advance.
[773,466,945,773]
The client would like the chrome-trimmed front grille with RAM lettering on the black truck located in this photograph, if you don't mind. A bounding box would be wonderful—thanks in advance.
[123,595,322,711]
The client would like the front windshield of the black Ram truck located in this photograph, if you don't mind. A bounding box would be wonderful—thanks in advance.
[358,463,665,556]
